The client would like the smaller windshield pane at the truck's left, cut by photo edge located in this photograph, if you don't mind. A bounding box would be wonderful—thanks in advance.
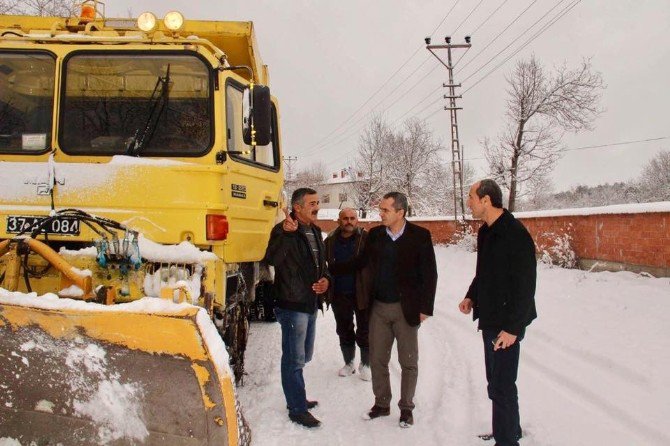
[0,52,56,154]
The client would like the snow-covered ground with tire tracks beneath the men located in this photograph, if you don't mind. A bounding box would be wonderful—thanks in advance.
[239,247,670,446]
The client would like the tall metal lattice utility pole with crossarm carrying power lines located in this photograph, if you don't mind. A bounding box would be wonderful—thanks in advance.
[425,36,472,220]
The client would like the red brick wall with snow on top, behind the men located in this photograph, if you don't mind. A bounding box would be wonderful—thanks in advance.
[319,212,670,269]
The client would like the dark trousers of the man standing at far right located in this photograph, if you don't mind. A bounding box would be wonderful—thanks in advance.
[482,330,521,446]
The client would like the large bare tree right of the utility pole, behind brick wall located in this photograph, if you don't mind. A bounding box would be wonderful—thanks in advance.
[484,56,605,211]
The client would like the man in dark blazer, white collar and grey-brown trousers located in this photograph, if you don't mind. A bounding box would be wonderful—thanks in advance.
[363,192,437,427]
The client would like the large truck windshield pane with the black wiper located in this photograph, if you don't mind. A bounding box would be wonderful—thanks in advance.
[59,53,213,156]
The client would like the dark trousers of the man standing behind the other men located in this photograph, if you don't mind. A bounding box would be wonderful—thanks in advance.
[333,294,370,365]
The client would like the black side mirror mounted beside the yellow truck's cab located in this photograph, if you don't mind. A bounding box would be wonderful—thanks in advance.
[242,85,272,146]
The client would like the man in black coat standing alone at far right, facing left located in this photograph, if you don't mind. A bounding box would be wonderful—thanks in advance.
[459,179,537,446]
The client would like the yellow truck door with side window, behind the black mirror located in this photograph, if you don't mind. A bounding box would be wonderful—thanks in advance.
[224,79,283,262]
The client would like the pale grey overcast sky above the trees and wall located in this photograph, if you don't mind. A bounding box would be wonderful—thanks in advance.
[107,0,670,190]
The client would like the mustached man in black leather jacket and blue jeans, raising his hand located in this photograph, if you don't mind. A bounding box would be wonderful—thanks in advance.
[265,188,330,428]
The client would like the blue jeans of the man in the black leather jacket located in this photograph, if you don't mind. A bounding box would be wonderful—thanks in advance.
[275,308,316,415]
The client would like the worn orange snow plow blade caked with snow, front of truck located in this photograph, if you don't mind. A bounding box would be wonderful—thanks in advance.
[0,296,248,445]
